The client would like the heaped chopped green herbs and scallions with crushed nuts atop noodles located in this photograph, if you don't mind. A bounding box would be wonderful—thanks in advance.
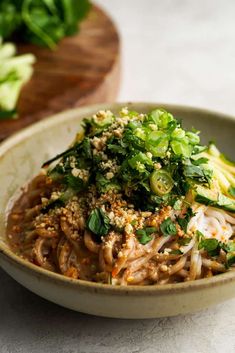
[40,109,215,212]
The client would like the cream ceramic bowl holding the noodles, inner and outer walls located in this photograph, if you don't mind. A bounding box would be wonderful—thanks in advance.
[0,103,235,318]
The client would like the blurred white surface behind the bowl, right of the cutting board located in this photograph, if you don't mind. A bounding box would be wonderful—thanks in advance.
[96,0,235,114]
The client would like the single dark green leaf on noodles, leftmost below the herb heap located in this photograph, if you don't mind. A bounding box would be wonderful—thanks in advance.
[87,208,110,237]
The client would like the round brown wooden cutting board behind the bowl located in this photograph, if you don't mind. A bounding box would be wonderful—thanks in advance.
[0,6,120,140]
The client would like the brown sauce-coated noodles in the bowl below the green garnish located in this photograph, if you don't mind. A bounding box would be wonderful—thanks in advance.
[8,177,235,285]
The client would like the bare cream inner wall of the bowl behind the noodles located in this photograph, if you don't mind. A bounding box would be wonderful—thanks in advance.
[0,103,235,270]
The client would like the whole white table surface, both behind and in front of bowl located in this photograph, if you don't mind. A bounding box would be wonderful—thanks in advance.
[0,0,235,353]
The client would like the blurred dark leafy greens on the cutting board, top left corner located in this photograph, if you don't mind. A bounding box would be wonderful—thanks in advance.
[0,0,90,49]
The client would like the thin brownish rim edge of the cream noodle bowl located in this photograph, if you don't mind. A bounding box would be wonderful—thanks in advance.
[0,102,235,296]
